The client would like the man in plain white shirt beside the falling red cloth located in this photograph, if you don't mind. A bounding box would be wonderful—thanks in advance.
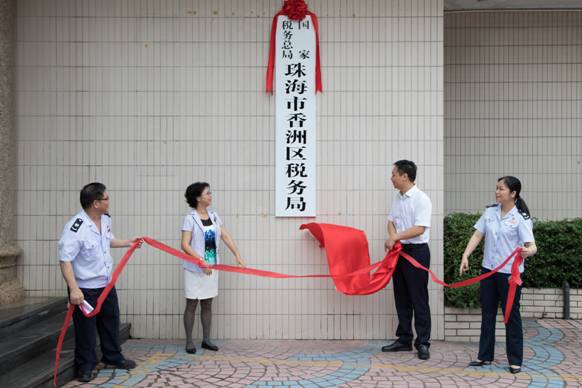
[382,160,432,360]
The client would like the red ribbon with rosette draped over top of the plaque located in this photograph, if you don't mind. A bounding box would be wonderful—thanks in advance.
[266,0,323,93]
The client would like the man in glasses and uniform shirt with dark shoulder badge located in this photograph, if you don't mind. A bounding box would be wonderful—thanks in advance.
[59,182,137,382]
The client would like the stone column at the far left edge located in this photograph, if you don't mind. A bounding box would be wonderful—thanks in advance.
[0,0,23,304]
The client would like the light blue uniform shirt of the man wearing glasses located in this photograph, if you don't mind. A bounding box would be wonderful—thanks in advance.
[59,210,114,288]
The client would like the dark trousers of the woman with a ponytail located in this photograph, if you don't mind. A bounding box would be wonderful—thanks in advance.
[478,268,523,366]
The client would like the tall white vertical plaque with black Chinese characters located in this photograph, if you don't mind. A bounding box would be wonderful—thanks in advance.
[275,15,316,217]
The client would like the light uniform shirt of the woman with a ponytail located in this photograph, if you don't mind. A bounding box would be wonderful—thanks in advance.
[475,205,534,273]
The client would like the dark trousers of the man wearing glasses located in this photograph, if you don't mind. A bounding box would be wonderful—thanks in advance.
[73,287,124,374]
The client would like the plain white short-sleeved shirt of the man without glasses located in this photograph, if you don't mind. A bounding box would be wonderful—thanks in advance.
[388,185,432,244]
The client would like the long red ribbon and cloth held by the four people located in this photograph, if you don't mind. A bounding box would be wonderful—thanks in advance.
[53,223,523,387]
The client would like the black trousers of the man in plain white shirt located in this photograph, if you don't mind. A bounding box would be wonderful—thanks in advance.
[392,244,431,348]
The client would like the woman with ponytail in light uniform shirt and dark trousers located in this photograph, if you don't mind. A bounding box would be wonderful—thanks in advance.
[459,176,537,373]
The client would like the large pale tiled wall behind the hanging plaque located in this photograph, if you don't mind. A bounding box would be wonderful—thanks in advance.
[17,0,444,339]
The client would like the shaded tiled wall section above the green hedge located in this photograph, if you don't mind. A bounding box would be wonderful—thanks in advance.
[445,11,582,219]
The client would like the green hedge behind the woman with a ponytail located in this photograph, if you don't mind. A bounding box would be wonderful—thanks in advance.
[444,213,582,308]
